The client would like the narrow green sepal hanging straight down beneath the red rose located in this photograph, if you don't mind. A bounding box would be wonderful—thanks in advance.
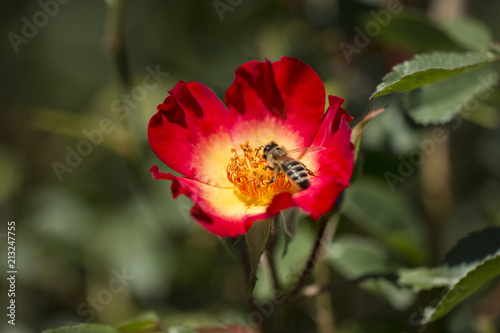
[245,219,271,296]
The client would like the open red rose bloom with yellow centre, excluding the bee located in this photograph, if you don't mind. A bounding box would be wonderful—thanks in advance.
[148,57,354,236]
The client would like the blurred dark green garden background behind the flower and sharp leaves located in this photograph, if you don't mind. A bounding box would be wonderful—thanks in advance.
[0,0,500,333]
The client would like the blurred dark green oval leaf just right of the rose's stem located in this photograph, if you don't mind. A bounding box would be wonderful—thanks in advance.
[343,178,426,265]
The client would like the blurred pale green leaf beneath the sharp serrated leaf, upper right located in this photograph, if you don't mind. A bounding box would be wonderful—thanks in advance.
[406,64,498,125]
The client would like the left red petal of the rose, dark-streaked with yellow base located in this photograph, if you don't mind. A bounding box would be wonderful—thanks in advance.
[148,81,234,186]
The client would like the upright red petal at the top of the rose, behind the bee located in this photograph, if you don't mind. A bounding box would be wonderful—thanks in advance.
[225,57,325,148]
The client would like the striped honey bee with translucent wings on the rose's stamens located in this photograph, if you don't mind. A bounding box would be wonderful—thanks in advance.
[255,141,326,190]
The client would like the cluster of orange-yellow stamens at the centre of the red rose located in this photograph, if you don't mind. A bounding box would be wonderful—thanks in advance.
[226,141,292,205]
